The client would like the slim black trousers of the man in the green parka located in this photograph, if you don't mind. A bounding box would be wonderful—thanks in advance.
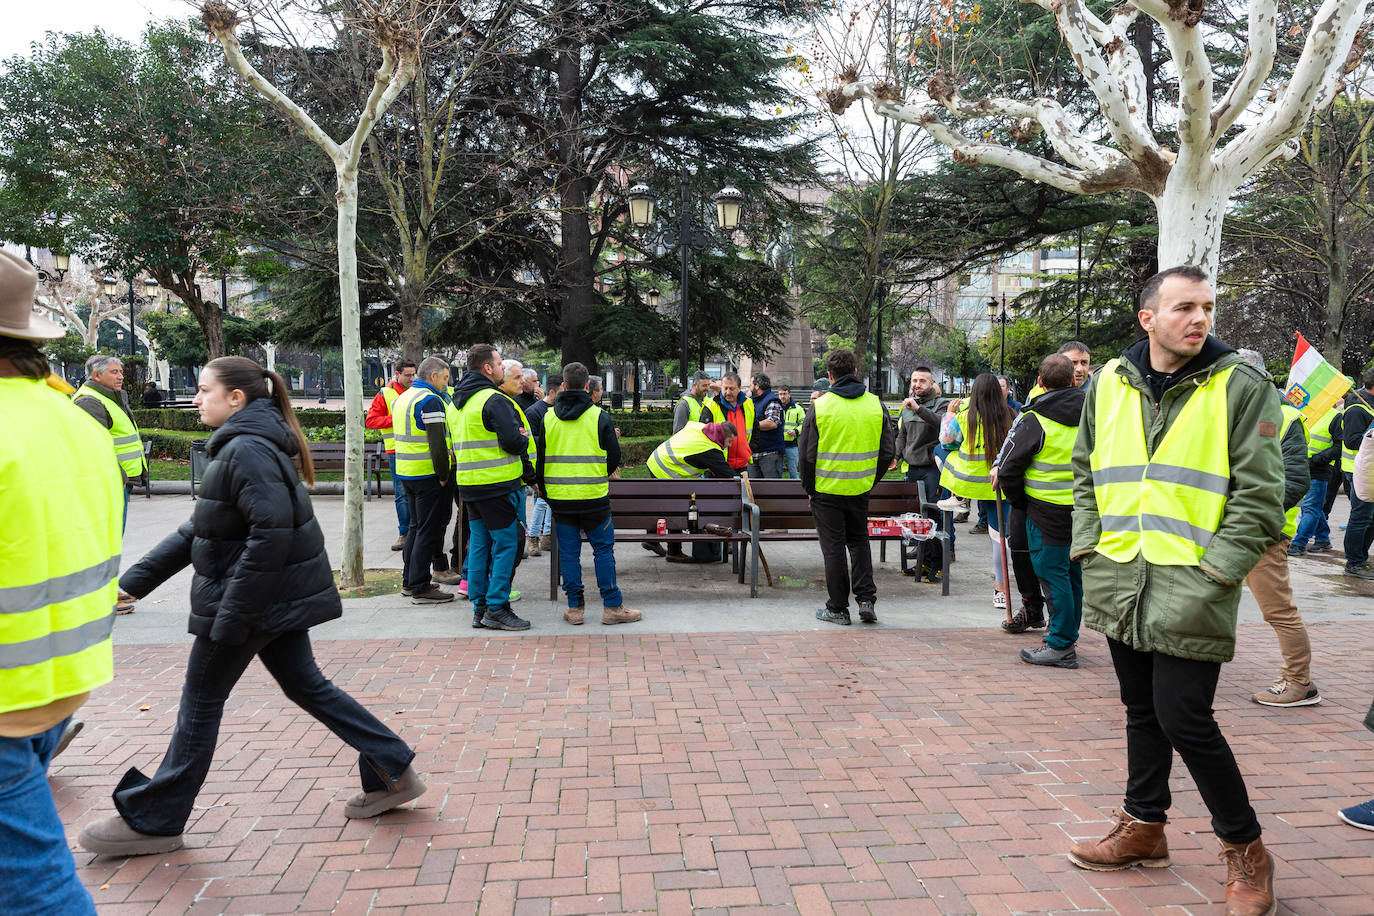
[1107,639,1260,843]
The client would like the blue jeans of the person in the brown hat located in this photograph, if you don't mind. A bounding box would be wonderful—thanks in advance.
[0,718,95,916]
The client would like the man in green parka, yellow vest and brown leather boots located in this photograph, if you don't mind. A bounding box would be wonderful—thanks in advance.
[1069,265,1283,913]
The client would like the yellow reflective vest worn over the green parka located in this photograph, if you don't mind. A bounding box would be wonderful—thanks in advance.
[1091,360,1234,566]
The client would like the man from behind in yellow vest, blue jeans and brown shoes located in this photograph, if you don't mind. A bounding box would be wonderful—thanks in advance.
[534,363,643,626]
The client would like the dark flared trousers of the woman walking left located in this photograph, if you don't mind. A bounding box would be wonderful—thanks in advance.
[114,630,415,836]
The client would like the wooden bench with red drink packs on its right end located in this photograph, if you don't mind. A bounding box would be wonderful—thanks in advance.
[741,478,949,597]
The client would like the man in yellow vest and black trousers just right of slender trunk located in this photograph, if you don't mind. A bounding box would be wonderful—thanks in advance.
[392,356,453,604]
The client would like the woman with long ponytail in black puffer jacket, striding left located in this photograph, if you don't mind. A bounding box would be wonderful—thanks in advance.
[80,356,425,856]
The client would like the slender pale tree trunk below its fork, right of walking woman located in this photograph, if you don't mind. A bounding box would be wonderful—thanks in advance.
[335,168,367,588]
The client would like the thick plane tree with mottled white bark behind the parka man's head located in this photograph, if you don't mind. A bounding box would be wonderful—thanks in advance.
[822,0,1370,276]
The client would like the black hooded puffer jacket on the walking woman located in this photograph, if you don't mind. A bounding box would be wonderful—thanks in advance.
[120,398,342,645]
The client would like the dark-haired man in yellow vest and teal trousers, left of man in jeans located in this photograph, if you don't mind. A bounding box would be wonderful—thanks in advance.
[453,343,533,630]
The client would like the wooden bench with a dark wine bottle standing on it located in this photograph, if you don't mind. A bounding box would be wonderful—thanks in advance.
[548,478,749,602]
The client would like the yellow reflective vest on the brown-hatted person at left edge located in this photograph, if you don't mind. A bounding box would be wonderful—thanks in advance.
[0,379,124,713]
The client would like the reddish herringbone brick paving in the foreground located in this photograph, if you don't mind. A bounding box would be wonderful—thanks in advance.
[61,622,1374,916]
